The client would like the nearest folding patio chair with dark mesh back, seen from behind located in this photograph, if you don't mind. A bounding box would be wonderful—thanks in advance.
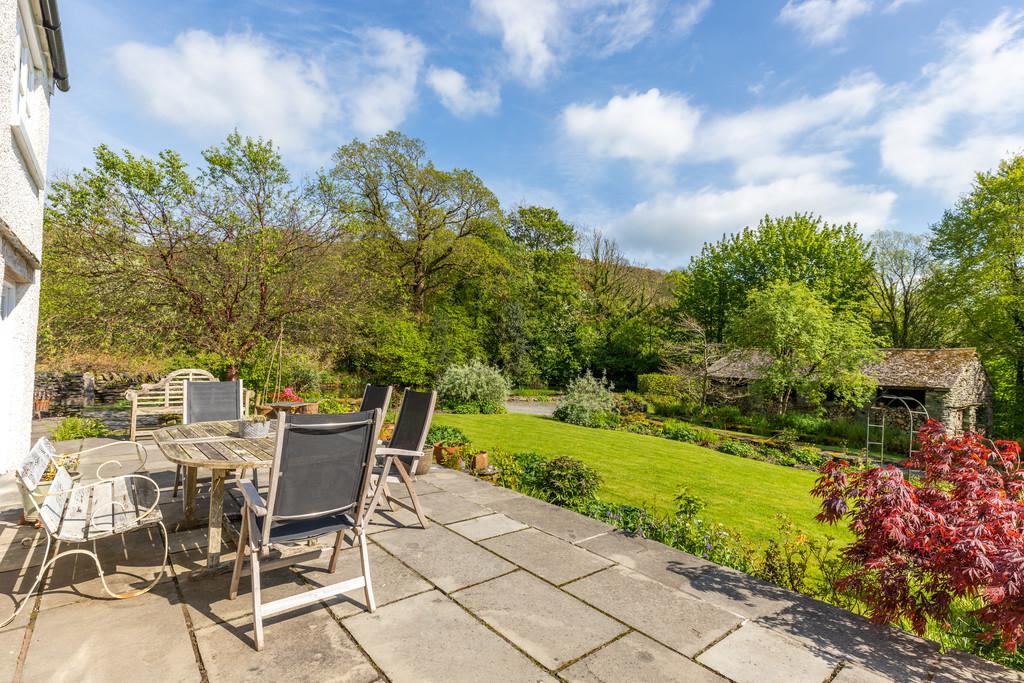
[228,410,383,650]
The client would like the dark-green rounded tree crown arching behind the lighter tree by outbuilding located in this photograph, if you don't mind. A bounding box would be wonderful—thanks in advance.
[676,214,871,342]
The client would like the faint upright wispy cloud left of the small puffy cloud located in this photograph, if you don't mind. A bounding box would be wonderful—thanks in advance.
[349,29,426,135]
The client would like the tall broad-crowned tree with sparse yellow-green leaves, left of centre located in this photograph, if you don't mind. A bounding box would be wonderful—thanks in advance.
[331,131,503,314]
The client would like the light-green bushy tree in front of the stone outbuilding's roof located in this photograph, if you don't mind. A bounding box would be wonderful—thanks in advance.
[733,282,879,415]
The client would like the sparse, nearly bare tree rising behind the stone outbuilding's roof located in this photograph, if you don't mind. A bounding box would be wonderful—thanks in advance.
[869,231,947,348]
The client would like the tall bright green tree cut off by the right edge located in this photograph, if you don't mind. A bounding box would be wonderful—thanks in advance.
[932,156,1024,434]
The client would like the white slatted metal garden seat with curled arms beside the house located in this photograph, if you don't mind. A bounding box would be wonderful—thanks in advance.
[0,437,168,627]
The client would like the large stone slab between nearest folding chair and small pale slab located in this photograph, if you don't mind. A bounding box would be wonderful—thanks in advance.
[371,525,515,593]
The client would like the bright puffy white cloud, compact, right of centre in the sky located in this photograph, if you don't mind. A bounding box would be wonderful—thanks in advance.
[562,88,700,163]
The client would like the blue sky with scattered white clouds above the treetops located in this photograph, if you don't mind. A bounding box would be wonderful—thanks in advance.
[49,0,1024,268]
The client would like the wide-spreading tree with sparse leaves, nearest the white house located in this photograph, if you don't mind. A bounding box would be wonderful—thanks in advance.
[47,133,337,378]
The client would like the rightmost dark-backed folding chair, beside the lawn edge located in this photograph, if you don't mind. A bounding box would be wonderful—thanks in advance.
[367,389,437,528]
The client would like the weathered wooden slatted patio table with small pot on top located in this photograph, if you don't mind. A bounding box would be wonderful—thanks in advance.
[153,420,276,569]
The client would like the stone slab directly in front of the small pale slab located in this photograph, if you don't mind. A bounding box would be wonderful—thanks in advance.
[480,528,611,585]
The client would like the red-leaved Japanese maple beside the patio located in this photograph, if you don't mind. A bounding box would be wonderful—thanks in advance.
[811,420,1024,648]
